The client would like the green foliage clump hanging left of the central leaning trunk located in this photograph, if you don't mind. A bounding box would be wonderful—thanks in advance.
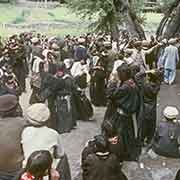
[67,0,121,32]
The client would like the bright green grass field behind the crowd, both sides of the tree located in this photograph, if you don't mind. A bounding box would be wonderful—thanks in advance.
[0,4,162,36]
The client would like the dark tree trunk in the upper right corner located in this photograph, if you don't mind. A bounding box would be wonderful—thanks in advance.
[156,0,180,39]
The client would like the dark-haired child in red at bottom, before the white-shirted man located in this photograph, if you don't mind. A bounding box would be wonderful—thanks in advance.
[13,150,59,180]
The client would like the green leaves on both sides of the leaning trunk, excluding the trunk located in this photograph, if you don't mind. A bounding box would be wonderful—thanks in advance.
[66,0,144,32]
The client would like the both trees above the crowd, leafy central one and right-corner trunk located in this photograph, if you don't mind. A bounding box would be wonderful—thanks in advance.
[66,0,180,39]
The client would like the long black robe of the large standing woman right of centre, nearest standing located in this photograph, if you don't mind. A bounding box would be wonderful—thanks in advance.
[105,79,140,160]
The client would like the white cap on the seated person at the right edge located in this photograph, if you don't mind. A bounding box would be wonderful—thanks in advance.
[163,106,179,120]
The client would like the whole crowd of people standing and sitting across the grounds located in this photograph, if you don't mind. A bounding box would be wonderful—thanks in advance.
[0,31,180,180]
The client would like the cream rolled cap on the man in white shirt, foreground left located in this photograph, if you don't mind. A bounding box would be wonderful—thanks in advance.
[25,103,50,126]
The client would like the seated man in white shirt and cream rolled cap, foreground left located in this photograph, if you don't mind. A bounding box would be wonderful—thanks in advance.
[21,103,71,180]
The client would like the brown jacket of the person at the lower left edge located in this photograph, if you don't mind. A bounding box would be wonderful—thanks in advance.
[0,117,26,172]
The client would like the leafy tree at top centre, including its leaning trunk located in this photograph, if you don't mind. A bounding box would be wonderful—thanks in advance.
[67,0,145,39]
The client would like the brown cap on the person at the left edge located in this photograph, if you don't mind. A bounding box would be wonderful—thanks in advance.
[0,94,18,112]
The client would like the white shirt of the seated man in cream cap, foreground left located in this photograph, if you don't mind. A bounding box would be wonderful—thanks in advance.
[21,126,64,168]
